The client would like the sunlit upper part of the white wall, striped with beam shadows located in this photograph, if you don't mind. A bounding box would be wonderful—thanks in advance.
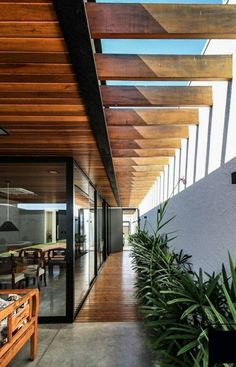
[139,40,236,218]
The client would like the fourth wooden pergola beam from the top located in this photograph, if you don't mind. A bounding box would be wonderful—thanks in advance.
[105,108,199,126]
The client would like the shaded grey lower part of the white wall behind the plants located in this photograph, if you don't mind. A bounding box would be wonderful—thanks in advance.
[141,158,236,272]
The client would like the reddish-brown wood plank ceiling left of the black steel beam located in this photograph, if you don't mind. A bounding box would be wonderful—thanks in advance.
[0,0,116,205]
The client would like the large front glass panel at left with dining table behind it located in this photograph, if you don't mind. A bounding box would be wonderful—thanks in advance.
[0,162,67,317]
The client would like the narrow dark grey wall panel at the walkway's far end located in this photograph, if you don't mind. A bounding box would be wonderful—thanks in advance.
[110,208,123,252]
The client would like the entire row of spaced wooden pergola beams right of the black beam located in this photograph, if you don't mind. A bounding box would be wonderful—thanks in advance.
[86,2,236,207]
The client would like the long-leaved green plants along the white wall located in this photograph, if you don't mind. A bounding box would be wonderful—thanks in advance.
[129,201,236,367]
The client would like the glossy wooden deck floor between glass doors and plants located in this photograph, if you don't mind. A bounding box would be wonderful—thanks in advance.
[76,251,138,322]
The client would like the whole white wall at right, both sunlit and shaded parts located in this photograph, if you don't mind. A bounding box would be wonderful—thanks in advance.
[139,7,236,271]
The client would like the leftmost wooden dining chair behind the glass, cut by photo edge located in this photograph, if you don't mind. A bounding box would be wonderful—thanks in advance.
[0,255,25,289]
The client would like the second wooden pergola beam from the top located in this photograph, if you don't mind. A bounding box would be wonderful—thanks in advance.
[95,54,232,81]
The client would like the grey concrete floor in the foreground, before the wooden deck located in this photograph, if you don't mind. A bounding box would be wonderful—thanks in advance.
[8,322,153,367]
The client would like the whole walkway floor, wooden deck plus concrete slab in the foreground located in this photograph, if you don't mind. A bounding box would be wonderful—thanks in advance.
[9,251,153,367]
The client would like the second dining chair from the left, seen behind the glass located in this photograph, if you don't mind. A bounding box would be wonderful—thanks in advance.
[17,248,47,291]
